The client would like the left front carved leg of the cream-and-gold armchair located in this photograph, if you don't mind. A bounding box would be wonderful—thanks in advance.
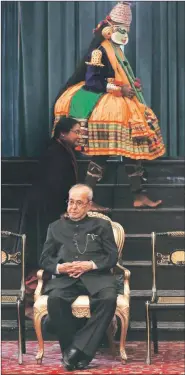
[34,307,47,364]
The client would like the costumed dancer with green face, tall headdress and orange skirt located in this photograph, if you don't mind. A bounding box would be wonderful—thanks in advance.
[54,2,165,208]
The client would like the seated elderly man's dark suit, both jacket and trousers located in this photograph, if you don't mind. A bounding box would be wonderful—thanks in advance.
[40,216,118,357]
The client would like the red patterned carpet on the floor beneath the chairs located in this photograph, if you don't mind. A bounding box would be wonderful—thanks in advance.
[1,341,185,375]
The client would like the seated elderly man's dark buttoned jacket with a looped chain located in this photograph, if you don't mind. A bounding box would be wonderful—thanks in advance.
[40,216,118,294]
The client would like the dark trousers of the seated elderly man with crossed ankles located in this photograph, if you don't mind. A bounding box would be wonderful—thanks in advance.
[48,280,117,357]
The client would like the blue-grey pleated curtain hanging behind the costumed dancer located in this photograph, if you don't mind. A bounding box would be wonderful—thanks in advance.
[2,1,185,157]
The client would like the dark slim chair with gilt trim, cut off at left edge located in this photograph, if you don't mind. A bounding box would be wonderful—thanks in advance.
[1,231,26,365]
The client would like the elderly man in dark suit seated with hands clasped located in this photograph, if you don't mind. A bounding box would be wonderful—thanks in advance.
[40,184,118,370]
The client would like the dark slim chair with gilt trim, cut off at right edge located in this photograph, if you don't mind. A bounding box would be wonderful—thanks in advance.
[145,231,185,365]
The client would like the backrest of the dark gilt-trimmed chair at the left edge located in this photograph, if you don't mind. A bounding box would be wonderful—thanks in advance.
[1,231,26,303]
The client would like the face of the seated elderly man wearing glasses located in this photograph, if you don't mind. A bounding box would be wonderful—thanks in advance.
[67,188,91,220]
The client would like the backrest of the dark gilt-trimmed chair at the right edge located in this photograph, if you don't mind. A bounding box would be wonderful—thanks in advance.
[151,231,185,302]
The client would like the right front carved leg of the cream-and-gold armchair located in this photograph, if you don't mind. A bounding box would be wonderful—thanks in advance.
[116,309,129,362]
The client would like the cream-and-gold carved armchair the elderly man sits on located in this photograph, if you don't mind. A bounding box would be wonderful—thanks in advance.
[33,212,130,363]
